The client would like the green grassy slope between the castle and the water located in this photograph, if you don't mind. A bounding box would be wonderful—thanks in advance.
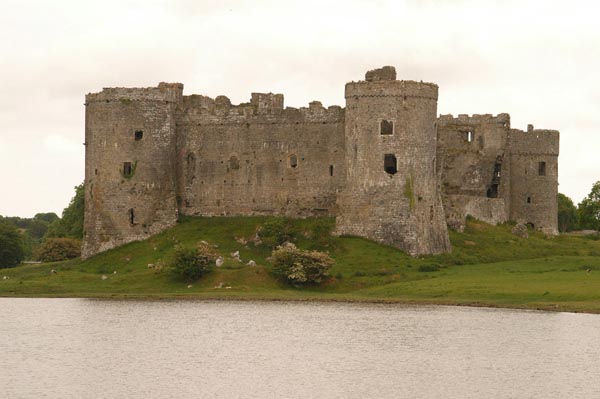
[0,217,600,313]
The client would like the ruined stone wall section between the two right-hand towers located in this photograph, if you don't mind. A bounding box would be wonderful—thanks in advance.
[437,114,510,231]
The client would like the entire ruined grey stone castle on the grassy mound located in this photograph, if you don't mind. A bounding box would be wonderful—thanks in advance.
[83,67,559,257]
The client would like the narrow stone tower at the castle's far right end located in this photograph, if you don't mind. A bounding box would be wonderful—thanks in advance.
[510,125,559,234]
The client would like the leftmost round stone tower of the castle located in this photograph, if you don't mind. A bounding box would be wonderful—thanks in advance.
[82,84,183,258]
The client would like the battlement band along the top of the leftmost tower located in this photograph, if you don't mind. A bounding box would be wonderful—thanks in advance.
[85,82,183,105]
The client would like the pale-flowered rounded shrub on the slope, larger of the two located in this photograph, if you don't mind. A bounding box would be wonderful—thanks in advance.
[271,243,334,285]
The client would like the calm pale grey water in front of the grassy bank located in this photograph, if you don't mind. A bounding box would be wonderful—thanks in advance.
[0,298,600,399]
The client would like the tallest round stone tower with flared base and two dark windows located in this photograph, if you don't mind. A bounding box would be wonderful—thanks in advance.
[336,66,450,255]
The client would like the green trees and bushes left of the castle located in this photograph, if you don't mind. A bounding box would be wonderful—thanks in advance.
[0,184,84,268]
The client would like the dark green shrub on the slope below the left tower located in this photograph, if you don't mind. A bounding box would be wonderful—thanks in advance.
[170,242,218,282]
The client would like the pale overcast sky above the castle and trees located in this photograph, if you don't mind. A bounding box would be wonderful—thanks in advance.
[0,0,600,217]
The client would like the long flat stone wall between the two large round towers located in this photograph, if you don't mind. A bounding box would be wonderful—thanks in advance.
[177,93,345,217]
